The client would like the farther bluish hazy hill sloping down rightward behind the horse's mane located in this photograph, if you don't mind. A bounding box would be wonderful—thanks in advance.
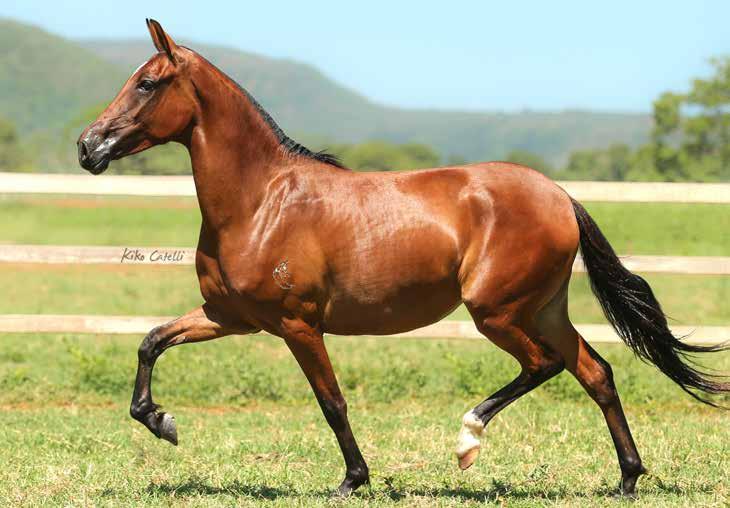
[81,40,651,163]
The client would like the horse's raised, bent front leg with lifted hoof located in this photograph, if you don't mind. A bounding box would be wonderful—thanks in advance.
[129,304,253,445]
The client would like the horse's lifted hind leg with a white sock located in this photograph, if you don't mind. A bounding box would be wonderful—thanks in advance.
[456,305,564,470]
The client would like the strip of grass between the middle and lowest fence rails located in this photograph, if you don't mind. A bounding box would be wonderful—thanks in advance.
[0,264,730,325]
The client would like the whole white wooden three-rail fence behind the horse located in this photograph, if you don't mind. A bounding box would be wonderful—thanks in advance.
[0,172,730,344]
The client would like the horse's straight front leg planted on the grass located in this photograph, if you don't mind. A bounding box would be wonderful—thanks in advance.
[282,319,370,496]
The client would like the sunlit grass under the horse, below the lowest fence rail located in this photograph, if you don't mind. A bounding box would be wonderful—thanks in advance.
[0,334,730,507]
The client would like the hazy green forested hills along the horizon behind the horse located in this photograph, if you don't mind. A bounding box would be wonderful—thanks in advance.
[0,20,651,164]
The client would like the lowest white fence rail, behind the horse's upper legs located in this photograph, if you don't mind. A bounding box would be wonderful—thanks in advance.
[0,314,730,344]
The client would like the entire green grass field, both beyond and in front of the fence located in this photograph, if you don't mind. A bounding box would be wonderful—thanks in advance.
[0,196,730,507]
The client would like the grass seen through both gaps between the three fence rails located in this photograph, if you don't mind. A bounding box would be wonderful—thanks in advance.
[0,195,730,325]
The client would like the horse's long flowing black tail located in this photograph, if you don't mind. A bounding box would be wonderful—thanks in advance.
[572,196,730,407]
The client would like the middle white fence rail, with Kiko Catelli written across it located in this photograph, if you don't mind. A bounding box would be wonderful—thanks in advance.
[0,245,730,275]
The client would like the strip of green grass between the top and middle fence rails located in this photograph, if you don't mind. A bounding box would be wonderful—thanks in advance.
[0,196,730,256]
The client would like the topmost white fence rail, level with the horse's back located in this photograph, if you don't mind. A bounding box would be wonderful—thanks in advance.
[0,172,730,204]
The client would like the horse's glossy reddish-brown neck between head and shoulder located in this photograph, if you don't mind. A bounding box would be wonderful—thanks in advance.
[186,60,286,233]
